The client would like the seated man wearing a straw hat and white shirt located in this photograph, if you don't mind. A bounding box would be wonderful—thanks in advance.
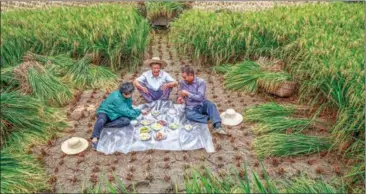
[134,57,178,102]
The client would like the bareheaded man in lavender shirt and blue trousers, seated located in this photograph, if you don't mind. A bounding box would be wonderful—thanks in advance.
[177,66,226,134]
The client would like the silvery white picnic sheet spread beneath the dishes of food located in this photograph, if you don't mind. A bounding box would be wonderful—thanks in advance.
[97,100,215,154]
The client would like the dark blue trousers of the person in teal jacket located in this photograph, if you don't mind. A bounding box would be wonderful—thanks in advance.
[92,113,130,139]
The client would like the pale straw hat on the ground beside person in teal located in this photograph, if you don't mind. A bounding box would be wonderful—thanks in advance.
[61,137,89,155]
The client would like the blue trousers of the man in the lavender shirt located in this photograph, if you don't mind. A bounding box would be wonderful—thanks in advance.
[186,100,221,128]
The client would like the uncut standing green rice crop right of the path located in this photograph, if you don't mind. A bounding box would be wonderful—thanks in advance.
[171,2,365,186]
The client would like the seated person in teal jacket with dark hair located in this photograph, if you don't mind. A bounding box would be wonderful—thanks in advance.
[91,82,141,150]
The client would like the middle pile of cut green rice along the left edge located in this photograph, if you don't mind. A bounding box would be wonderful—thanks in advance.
[1,92,65,151]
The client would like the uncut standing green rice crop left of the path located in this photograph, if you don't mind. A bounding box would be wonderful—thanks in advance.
[1,5,150,70]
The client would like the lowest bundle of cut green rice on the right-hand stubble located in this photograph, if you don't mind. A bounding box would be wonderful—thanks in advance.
[253,133,331,157]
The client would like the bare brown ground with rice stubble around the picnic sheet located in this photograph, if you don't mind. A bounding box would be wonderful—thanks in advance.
[36,29,343,193]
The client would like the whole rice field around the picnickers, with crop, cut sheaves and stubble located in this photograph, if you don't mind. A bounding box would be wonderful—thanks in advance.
[0,1,365,193]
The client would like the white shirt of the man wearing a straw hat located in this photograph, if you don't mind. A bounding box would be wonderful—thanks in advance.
[137,70,175,91]
